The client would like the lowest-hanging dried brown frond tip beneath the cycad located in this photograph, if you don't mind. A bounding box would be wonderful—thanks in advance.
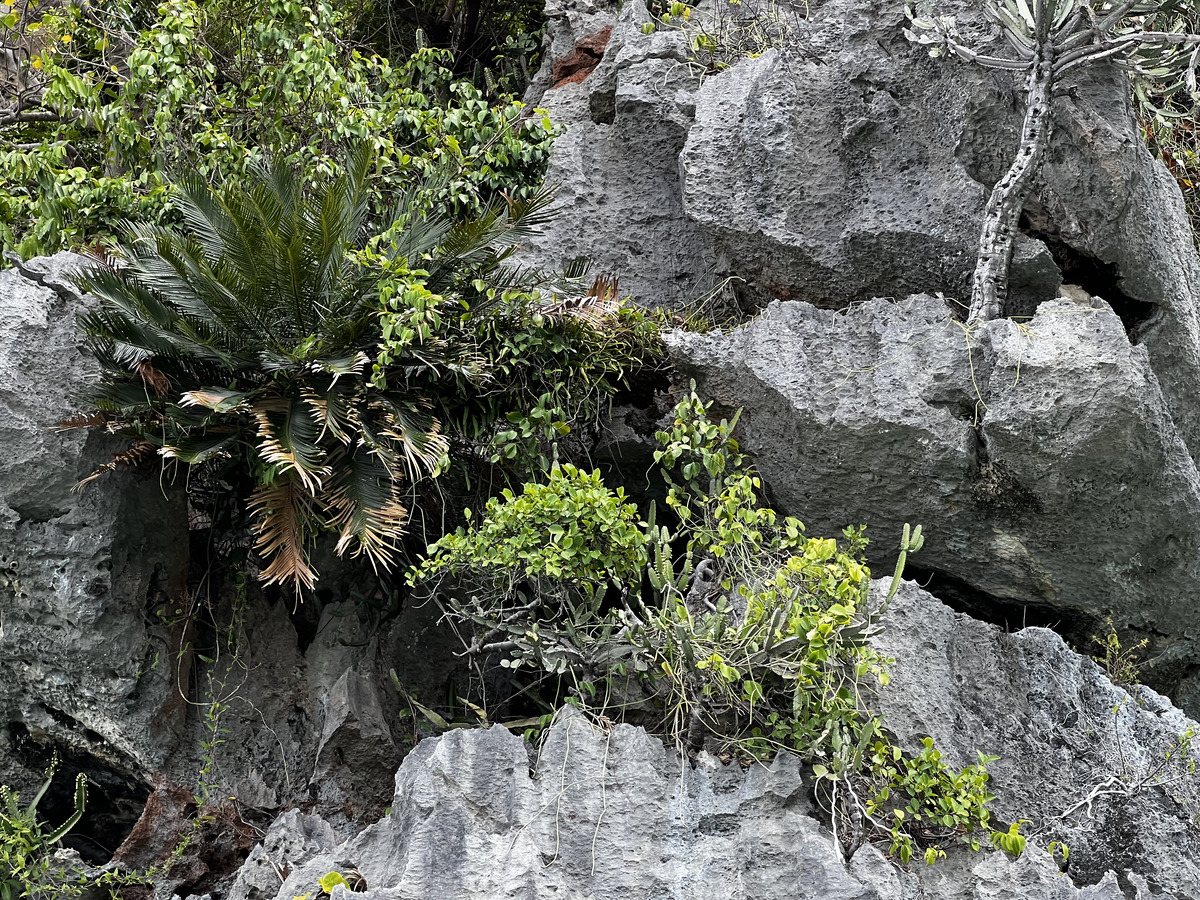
[250,478,317,596]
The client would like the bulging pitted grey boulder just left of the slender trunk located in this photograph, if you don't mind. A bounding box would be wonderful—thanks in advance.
[680,38,985,306]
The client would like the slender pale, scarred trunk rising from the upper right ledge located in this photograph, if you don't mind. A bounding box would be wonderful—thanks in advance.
[967,48,1054,322]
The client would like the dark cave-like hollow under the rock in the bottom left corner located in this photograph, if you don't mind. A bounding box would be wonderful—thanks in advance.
[4,720,150,865]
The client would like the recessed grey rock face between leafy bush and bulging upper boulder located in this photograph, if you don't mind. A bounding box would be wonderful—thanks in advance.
[523,0,720,306]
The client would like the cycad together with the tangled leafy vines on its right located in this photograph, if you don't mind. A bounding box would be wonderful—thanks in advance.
[79,145,656,588]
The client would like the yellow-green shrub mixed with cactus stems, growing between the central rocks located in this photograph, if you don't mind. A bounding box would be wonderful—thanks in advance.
[413,394,1020,863]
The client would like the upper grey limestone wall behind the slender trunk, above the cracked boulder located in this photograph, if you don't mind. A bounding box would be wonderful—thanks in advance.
[527,0,1200,448]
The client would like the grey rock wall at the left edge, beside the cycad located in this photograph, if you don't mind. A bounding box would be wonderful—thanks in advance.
[0,253,188,796]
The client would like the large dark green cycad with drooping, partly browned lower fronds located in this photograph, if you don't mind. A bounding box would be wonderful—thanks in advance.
[78,149,554,589]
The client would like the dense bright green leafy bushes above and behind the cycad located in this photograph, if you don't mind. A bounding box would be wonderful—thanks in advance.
[0,0,554,257]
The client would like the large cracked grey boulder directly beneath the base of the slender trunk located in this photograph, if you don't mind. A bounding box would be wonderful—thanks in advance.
[668,296,1200,705]
